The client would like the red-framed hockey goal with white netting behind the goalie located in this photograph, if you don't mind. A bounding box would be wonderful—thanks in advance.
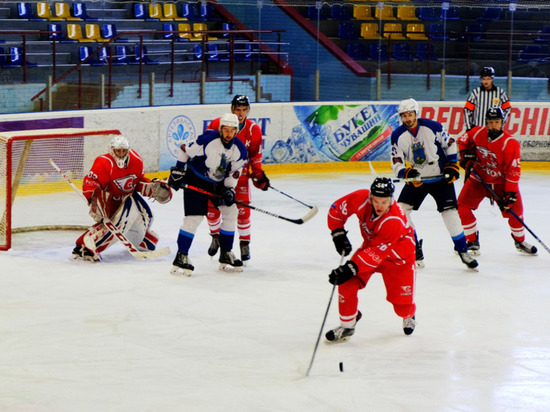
[0,128,120,250]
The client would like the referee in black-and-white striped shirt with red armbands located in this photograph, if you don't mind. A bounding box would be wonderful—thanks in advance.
[464,67,512,130]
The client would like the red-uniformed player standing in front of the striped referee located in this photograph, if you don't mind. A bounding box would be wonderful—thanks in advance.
[458,107,537,255]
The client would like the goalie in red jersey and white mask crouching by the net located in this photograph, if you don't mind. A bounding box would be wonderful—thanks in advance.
[72,135,172,261]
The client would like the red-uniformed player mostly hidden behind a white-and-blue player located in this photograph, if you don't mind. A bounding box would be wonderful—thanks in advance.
[207,95,269,262]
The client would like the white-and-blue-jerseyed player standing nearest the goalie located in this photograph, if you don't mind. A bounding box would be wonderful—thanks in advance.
[168,113,247,276]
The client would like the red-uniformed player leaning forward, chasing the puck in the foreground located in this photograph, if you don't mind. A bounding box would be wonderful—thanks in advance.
[325,177,416,342]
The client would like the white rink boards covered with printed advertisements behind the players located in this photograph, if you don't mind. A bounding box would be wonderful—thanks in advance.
[0,101,550,173]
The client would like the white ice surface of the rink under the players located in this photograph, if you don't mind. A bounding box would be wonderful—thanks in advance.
[0,172,550,412]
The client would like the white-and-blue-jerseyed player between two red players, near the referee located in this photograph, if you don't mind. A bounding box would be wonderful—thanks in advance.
[391,99,478,270]
